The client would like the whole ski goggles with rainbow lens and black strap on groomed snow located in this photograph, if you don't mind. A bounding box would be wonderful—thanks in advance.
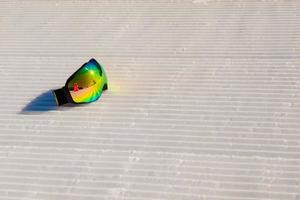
[53,58,108,106]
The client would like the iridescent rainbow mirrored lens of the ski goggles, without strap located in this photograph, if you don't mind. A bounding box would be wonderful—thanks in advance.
[67,59,107,103]
